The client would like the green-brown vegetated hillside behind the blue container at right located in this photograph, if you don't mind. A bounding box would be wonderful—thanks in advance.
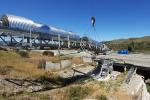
[105,36,150,53]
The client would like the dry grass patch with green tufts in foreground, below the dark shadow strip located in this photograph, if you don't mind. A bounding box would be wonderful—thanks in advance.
[39,75,132,100]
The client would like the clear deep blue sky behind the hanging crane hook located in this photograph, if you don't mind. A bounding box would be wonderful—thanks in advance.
[0,0,150,41]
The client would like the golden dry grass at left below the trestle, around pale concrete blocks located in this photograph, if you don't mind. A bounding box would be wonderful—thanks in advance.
[0,50,83,78]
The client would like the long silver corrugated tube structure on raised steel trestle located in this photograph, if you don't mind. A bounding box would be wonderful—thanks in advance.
[0,14,104,50]
